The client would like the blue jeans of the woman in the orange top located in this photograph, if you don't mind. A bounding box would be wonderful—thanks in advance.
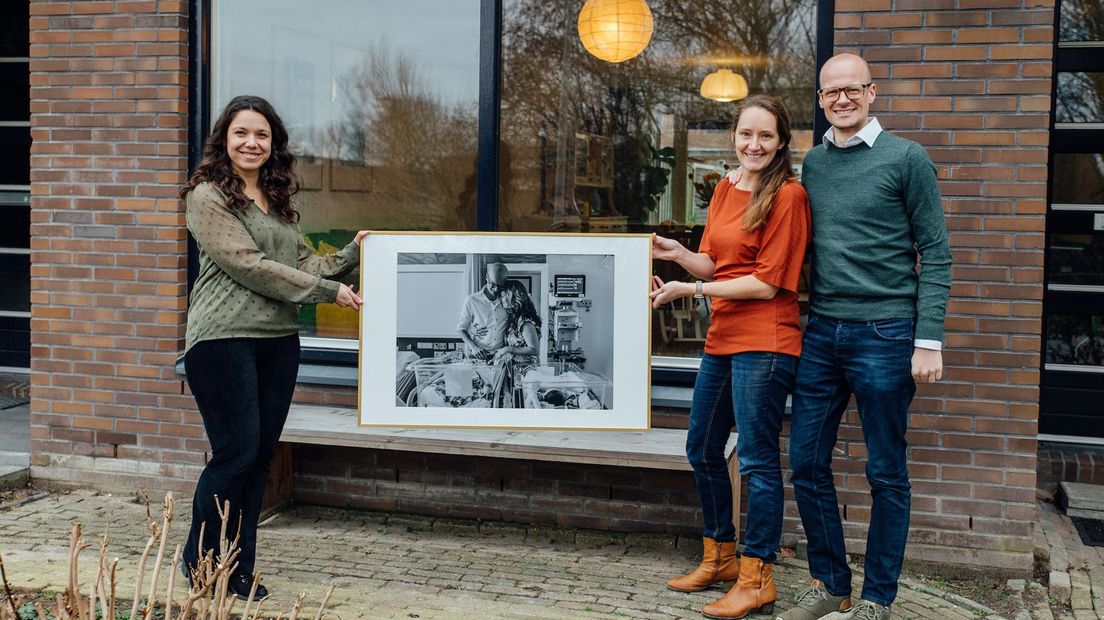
[687,352,797,563]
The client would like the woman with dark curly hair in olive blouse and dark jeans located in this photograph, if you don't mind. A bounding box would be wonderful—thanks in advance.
[180,96,367,599]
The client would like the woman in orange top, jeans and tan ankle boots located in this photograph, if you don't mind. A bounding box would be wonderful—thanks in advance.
[651,95,810,618]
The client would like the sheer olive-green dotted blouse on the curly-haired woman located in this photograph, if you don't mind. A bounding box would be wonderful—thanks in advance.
[185,183,360,351]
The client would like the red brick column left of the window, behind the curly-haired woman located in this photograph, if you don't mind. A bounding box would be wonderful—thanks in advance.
[31,0,198,490]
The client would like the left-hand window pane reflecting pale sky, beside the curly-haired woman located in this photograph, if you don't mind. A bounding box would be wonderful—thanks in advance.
[211,0,479,339]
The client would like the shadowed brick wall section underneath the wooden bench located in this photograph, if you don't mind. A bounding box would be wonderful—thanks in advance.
[294,446,701,536]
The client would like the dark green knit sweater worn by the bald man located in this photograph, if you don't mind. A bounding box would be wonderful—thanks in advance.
[802,131,951,341]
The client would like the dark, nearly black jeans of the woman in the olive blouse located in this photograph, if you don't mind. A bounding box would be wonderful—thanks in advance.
[182,335,299,575]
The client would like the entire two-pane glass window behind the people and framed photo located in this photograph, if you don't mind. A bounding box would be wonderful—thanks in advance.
[211,0,816,356]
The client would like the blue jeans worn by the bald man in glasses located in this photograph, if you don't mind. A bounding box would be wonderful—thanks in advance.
[789,314,916,606]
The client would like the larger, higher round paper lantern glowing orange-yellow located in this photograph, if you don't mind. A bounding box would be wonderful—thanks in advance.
[578,0,652,63]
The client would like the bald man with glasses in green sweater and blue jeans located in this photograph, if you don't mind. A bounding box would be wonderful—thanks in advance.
[777,54,951,620]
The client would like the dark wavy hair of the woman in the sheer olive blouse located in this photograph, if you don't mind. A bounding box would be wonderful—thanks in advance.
[180,95,299,224]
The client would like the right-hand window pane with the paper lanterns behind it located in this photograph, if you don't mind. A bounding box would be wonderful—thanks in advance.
[498,0,816,356]
